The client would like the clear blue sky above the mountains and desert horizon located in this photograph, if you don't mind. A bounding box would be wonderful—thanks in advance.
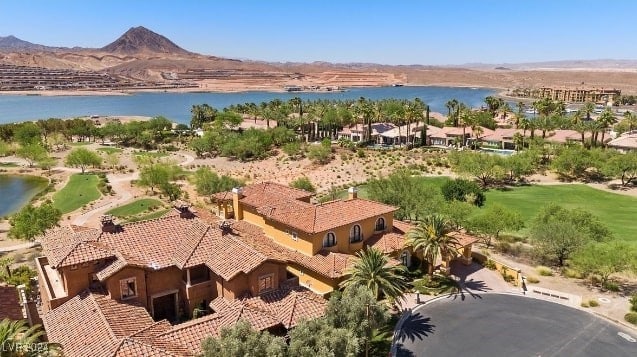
[0,0,637,65]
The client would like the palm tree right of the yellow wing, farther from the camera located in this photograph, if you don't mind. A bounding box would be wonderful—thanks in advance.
[405,215,459,277]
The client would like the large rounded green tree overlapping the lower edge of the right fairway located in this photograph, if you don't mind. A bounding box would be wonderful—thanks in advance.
[530,204,612,266]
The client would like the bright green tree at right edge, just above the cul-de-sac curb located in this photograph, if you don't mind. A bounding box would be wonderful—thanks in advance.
[570,241,637,286]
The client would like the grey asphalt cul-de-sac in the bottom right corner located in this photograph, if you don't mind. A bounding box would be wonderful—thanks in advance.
[396,294,637,357]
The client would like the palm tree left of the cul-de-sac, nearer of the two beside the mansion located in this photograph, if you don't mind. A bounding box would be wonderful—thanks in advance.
[341,248,407,300]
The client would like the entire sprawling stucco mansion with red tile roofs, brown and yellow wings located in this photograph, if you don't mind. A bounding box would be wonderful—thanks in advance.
[36,182,473,356]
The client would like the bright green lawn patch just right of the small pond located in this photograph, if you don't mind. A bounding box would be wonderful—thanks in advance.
[53,174,101,213]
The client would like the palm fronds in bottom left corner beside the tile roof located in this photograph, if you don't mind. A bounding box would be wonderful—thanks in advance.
[0,319,61,357]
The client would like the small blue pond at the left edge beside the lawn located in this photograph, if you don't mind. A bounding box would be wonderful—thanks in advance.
[0,174,47,217]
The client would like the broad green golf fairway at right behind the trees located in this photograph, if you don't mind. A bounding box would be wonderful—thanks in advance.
[485,184,637,244]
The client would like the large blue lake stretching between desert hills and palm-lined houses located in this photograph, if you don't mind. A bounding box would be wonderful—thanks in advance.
[0,86,496,124]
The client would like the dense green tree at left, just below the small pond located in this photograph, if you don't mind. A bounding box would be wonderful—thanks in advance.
[9,201,62,241]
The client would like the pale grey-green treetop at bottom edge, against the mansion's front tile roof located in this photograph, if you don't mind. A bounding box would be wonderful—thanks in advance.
[202,320,287,357]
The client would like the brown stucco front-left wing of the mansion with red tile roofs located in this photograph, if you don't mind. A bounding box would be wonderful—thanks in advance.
[36,205,326,356]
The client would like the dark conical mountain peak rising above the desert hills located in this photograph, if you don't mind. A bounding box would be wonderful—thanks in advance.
[101,26,190,54]
